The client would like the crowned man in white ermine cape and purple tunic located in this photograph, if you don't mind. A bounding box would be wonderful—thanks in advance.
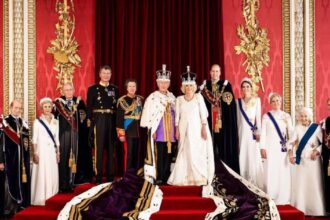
[140,64,176,184]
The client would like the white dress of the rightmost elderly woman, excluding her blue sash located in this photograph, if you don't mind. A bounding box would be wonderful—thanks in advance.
[288,125,325,216]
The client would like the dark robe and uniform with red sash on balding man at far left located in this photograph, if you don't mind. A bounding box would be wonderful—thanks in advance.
[0,115,31,215]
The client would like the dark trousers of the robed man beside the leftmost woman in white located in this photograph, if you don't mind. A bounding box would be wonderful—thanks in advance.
[59,129,78,191]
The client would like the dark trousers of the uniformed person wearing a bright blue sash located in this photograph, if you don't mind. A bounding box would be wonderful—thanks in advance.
[126,137,139,169]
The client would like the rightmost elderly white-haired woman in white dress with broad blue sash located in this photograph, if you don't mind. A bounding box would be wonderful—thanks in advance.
[287,108,325,216]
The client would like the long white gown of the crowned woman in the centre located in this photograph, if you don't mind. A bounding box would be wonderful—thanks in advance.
[168,93,214,186]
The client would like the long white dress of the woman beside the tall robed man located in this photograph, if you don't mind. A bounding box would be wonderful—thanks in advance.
[236,97,264,189]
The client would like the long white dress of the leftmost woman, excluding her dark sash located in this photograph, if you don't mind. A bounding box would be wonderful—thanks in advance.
[31,116,60,205]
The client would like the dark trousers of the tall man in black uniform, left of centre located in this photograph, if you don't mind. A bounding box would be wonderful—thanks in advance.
[94,113,116,183]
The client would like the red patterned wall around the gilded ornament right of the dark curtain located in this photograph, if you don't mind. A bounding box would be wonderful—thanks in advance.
[222,0,283,115]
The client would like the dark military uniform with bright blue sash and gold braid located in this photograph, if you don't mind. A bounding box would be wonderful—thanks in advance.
[116,95,143,169]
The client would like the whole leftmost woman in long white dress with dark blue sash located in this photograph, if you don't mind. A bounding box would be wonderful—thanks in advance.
[31,97,60,205]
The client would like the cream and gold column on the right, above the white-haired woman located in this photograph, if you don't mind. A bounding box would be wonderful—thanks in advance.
[282,0,315,121]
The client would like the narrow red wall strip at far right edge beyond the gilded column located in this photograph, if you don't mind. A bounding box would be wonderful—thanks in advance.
[315,1,330,121]
